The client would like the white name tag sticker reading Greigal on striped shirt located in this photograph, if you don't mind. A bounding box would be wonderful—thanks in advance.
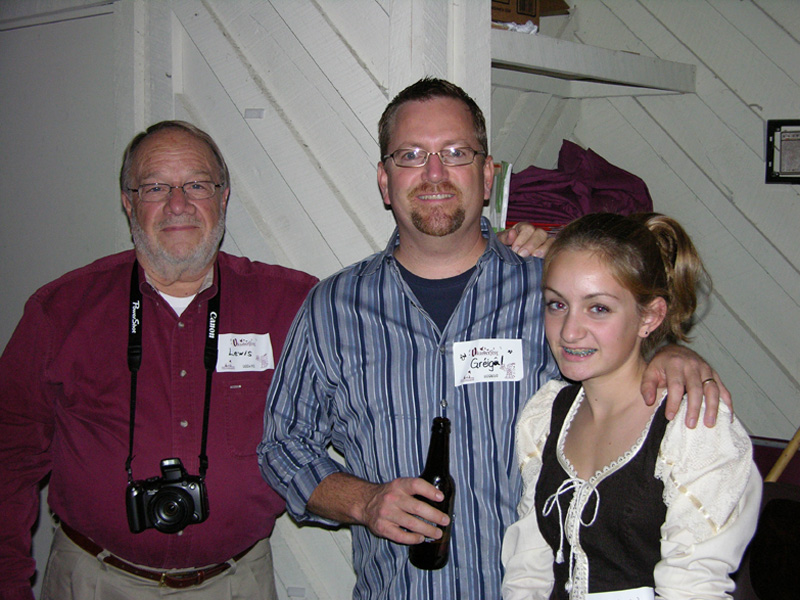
[453,339,524,386]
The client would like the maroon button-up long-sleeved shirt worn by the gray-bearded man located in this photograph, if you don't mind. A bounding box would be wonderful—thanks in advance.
[0,251,316,598]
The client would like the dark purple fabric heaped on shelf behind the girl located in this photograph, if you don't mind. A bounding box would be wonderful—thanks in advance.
[506,140,653,226]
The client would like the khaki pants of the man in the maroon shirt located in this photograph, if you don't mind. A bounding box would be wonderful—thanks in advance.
[41,528,278,600]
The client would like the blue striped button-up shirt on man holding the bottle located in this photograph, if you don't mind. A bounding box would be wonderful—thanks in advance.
[259,220,558,600]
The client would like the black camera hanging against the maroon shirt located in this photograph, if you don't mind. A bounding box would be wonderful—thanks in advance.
[125,458,208,533]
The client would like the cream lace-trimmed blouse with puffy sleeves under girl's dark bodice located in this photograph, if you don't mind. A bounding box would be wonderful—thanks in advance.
[502,381,761,600]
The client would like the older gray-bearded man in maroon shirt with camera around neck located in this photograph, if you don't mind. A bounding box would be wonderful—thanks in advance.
[0,121,316,600]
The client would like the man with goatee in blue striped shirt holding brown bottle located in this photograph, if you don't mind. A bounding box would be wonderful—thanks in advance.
[259,78,728,600]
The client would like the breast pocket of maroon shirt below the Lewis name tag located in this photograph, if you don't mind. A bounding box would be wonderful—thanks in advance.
[220,374,269,460]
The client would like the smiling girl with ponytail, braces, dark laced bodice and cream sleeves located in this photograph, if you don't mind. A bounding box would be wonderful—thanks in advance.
[503,213,761,600]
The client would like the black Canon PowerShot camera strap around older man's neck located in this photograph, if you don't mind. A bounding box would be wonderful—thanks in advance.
[125,260,222,482]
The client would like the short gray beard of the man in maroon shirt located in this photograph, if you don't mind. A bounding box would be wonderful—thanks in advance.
[130,210,225,281]
